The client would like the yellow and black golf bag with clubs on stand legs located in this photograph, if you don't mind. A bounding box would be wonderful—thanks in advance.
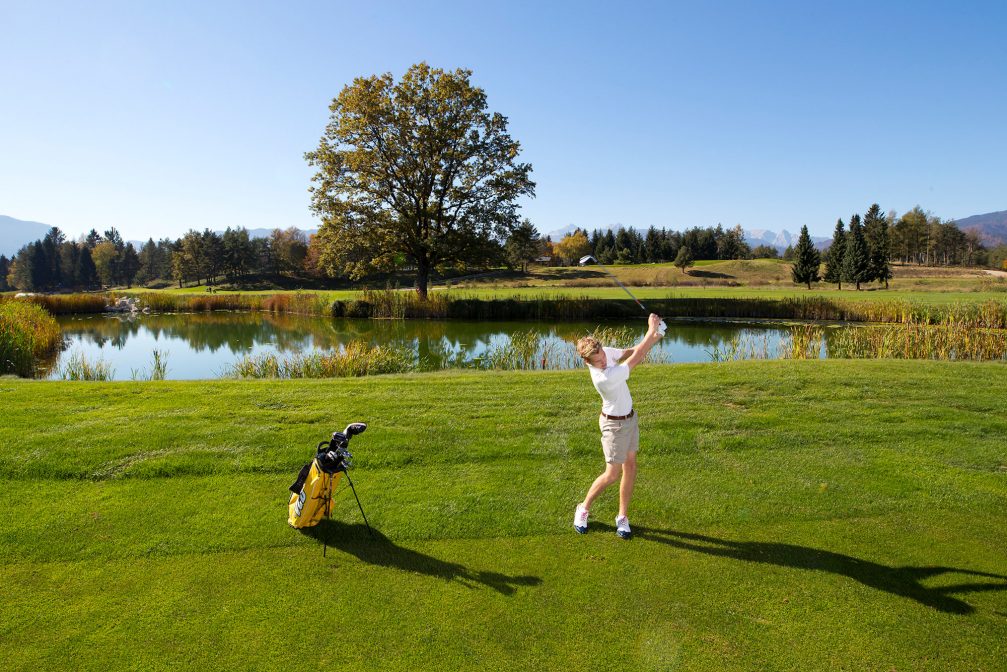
[287,422,374,555]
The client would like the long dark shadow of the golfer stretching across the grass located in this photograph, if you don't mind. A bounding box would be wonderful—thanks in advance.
[633,527,1007,614]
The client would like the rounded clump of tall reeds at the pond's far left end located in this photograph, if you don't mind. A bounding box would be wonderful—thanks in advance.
[0,299,62,378]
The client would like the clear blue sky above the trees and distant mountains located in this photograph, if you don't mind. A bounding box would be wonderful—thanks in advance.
[0,0,1007,240]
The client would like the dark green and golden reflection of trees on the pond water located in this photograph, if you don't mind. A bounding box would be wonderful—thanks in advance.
[59,311,809,369]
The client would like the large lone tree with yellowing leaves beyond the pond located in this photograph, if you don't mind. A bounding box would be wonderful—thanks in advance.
[305,63,535,298]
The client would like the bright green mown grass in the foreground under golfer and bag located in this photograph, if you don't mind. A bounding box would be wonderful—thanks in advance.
[0,361,1007,671]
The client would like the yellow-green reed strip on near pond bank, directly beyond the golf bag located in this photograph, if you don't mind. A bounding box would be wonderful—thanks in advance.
[226,341,418,378]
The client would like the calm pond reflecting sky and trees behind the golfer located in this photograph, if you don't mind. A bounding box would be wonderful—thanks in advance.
[49,311,832,380]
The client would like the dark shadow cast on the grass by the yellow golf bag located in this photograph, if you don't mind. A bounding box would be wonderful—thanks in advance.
[300,518,542,595]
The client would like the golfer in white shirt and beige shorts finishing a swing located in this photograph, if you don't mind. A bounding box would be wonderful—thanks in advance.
[573,312,664,539]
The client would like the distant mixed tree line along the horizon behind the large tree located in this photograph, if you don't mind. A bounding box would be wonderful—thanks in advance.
[0,204,1007,291]
